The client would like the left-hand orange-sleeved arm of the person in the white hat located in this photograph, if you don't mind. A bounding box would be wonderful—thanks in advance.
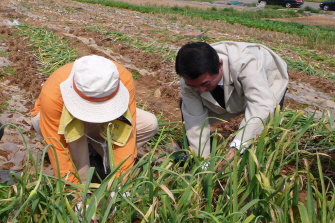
[35,63,83,183]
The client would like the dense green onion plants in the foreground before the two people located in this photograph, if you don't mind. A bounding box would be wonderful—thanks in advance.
[0,109,335,223]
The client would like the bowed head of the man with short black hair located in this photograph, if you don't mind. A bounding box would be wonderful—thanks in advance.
[176,42,222,92]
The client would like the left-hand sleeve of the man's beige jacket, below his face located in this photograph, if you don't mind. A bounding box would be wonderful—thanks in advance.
[181,79,210,156]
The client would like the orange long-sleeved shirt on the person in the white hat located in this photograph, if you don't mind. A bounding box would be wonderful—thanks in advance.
[31,61,137,183]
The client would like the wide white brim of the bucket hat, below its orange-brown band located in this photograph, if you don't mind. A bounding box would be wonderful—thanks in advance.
[60,72,129,123]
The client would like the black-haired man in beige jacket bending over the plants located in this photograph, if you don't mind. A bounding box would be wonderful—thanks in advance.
[175,41,289,167]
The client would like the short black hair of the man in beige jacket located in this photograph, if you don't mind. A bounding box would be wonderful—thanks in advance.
[175,42,220,80]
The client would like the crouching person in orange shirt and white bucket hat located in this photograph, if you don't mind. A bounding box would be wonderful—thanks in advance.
[31,55,158,184]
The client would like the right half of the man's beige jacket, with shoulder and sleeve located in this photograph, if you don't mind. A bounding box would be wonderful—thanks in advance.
[212,41,288,151]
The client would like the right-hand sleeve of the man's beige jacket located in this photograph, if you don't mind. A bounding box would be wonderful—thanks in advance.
[232,47,276,147]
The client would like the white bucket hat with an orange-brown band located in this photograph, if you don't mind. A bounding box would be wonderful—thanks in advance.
[60,55,129,123]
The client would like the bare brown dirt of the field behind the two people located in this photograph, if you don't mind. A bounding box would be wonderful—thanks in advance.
[0,0,335,182]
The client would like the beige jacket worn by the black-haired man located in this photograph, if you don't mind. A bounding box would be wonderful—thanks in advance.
[181,41,288,156]
